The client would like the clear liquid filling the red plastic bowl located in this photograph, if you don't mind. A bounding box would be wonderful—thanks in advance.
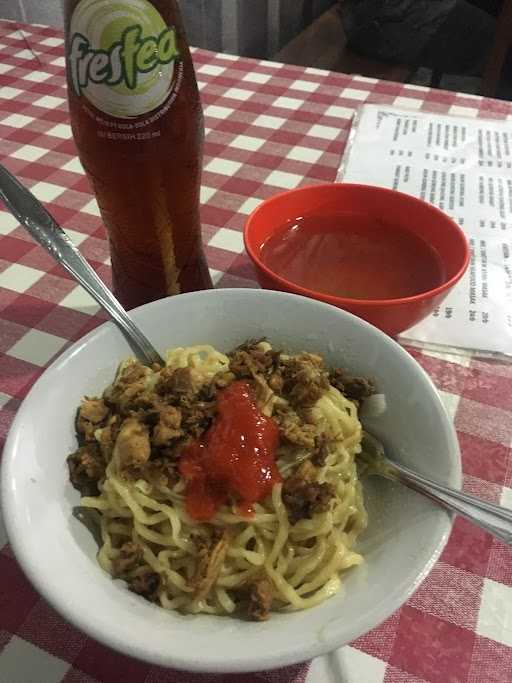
[261,212,445,299]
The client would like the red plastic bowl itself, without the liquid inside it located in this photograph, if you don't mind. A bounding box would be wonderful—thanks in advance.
[244,183,470,336]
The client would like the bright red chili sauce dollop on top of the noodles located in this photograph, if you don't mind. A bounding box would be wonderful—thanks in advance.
[179,381,281,522]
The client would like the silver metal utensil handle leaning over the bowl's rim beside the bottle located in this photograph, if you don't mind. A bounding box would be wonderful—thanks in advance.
[0,164,164,365]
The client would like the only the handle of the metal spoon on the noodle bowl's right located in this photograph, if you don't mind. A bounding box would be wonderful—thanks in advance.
[386,458,512,545]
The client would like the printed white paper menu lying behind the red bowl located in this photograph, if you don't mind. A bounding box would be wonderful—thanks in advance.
[338,104,512,355]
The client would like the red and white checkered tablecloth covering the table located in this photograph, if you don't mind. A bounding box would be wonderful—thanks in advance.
[0,21,512,683]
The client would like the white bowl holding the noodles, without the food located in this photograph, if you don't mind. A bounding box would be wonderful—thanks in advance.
[2,289,460,672]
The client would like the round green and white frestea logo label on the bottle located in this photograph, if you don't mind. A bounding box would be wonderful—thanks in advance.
[68,0,180,119]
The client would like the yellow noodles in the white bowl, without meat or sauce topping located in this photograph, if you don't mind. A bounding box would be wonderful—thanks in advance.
[81,342,367,615]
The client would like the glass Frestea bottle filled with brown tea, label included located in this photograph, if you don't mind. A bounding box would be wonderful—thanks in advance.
[65,0,212,308]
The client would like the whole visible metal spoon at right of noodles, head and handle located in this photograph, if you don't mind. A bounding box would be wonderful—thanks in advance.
[360,432,512,545]
